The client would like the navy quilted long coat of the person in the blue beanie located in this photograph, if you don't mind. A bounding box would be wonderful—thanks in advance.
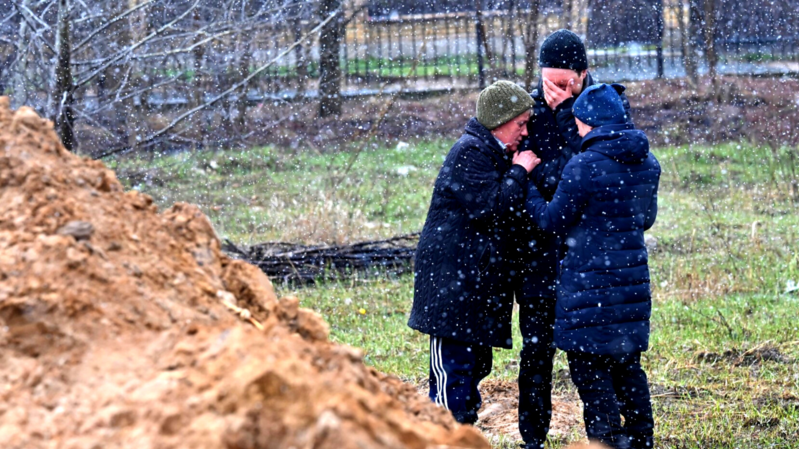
[525,124,660,355]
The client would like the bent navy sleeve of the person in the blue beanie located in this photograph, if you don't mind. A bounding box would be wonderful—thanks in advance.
[525,157,588,233]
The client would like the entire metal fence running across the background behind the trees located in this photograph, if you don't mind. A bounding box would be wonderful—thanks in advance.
[109,0,799,103]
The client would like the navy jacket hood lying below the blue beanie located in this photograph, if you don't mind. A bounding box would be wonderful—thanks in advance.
[582,123,649,164]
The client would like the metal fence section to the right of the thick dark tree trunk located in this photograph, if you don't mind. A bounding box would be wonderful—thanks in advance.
[332,0,799,89]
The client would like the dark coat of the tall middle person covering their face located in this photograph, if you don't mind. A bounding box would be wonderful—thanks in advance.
[512,73,632,300]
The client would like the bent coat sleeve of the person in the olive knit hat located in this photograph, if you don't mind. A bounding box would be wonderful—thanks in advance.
[449,149,527,222]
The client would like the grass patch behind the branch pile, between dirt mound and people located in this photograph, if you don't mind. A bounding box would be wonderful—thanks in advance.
[112,142,448,243]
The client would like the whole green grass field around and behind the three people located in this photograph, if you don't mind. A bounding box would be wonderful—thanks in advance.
[112,141,799,449]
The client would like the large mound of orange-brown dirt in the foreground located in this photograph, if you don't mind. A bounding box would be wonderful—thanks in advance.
[0,97,489,449]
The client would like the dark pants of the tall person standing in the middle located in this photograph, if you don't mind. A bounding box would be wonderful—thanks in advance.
[517,298,555,449]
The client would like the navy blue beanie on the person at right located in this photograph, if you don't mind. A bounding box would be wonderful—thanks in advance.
[573,83,627,128]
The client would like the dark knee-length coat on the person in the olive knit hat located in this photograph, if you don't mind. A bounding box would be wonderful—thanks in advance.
[408,119,527,348]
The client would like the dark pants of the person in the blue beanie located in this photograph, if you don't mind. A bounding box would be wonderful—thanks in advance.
[567,352,655,449]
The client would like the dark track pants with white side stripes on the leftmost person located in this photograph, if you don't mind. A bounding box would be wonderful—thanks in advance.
[430,337,493,424]
